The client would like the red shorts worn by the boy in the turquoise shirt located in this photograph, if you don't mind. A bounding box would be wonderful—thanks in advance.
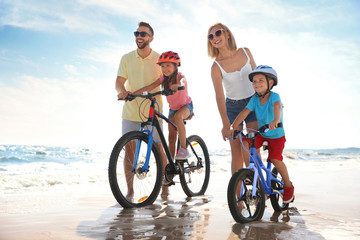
[243,134,286,161]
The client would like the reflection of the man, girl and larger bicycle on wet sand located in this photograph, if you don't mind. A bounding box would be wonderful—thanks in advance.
[78,197,210,240]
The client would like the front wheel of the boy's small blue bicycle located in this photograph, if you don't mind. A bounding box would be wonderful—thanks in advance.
[227,169,266,223]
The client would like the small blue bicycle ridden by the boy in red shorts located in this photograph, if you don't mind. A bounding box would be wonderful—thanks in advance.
[227,123,289,223]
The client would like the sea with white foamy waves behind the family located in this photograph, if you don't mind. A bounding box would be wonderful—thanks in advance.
[0,145,360,194]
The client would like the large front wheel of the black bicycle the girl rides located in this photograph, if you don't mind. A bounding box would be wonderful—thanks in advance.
[108,131,162,208]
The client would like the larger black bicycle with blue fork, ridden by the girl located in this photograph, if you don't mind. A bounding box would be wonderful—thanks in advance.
[108,87,210,208]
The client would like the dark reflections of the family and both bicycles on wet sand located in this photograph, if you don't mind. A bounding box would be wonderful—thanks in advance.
[78,196,325,240]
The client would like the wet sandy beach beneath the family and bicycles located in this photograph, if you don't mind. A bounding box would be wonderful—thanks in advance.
[0,160,360,240]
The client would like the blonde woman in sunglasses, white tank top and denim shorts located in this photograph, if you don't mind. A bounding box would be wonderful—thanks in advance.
[207,23,258,173]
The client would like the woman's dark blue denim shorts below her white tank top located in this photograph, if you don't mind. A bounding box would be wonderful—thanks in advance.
[226,97,257,126]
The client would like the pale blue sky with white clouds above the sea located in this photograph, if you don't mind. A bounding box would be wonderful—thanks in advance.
[0,0,360,150]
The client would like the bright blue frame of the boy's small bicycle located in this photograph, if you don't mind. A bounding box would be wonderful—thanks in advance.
[239,129,284,198]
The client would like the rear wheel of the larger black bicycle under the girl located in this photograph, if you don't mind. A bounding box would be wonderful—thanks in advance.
[177,135,210,197]
